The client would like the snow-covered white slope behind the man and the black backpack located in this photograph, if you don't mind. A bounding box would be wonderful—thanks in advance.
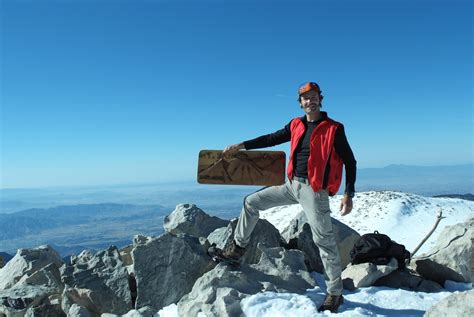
[260,191,474,255]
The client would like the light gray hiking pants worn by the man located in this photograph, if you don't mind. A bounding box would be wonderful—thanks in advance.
[234,178,342,295]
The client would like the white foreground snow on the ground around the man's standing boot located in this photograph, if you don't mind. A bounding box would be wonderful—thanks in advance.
[155,273,472,317]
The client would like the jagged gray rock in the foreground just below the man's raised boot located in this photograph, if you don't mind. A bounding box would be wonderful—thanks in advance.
[178,244,316,317]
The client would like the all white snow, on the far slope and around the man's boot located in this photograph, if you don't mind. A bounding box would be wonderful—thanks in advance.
[155,191,474,317]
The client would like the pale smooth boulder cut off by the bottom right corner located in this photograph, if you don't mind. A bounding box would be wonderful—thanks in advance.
[423,290,474,317]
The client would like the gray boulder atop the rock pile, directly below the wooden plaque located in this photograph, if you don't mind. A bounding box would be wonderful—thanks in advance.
[163,204,229,237]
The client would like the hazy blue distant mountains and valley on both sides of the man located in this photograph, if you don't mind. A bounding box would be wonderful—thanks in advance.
[0,164,474,256]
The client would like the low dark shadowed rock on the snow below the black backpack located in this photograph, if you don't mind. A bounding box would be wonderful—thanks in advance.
[373,270,443,293]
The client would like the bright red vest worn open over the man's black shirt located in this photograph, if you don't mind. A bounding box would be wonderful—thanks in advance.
[287,118,343,196]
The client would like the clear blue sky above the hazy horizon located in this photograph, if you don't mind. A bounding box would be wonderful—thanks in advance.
[0,0,474,188]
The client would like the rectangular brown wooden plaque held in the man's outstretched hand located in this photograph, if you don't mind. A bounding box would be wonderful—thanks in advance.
[197,150,285,186]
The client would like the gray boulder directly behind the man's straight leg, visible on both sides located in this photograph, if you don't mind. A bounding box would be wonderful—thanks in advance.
[282,212,360,273]
